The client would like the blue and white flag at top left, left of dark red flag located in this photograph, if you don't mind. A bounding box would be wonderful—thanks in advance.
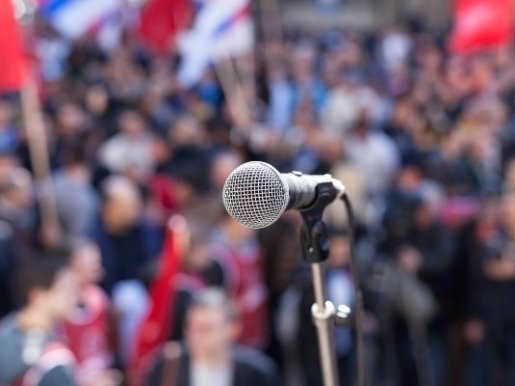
[40,0,123,46]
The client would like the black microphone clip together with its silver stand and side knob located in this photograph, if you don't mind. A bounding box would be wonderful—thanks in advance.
[299,182,350,386]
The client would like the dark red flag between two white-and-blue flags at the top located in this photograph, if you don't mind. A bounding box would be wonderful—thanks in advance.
[139,0,193,54]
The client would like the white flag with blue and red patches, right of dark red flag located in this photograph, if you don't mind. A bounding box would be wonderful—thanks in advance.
[178,0,254,87]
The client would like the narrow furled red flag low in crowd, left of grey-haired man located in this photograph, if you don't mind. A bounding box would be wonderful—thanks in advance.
[129,216,187,386]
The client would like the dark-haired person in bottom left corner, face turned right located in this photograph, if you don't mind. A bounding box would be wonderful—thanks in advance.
[0,247,79,386]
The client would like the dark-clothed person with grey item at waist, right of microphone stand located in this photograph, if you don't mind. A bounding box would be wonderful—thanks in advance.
[378,185,454,385]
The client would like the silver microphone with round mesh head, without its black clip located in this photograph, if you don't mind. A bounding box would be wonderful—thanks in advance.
[223,161,345,229]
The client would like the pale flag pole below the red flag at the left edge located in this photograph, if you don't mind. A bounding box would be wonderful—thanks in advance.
[21,76,61,246]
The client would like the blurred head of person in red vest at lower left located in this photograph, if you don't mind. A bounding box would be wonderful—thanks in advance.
[70,239,104,287]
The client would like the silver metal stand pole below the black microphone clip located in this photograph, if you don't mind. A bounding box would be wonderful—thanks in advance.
[311,263,340,386]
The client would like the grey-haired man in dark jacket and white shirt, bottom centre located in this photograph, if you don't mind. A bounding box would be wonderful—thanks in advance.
[148,289,282,386]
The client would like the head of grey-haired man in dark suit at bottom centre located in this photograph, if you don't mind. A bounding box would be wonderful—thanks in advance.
[185,289,240,361]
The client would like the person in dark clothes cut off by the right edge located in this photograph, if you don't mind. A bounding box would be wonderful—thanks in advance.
[464,192,515,386]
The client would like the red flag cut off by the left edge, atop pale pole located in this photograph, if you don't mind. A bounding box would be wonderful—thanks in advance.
[0,0,24,93]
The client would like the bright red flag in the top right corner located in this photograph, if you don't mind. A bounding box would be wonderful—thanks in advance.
[449,0,513,54]
